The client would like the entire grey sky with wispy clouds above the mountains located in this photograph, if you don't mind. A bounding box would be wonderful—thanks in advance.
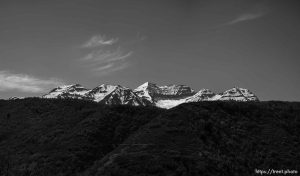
[0,0,300,101]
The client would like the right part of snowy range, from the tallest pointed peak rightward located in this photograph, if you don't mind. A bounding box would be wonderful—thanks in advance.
[134,82,258,109]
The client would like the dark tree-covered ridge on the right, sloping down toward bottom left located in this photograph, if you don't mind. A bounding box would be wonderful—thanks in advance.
[86,102,300,176]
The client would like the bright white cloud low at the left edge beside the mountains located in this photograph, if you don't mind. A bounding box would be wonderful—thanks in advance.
[0,70,64,93]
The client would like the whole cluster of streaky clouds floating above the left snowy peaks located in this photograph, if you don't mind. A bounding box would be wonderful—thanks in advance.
[80,35,133,75]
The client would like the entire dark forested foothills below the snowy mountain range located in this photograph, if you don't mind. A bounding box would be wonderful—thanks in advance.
[0,99,300,176]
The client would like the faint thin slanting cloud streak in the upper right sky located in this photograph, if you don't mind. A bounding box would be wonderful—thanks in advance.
[226,5,269,25]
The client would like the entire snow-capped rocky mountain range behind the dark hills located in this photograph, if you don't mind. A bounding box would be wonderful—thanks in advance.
[42,82,259,109]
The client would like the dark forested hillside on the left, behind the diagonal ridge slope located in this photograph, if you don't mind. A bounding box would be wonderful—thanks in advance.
[0,99,163,176]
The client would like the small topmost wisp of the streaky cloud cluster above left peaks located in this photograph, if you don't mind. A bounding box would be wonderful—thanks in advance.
[82,35,119,48]
